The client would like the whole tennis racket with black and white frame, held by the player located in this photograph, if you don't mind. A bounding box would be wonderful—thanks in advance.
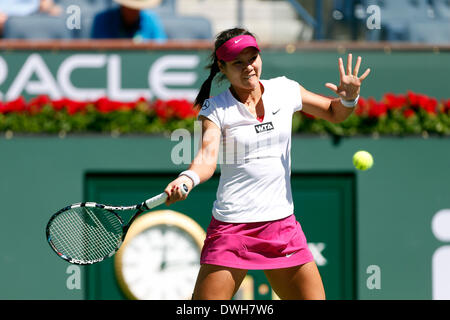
[46,184,189,265]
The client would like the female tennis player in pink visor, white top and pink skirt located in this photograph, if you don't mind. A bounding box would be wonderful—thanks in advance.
[165,28,370,300]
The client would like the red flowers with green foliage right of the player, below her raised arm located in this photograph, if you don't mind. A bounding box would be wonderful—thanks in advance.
[294,92,450,136]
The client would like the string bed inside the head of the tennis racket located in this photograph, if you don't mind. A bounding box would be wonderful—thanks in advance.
[50,207,122,262]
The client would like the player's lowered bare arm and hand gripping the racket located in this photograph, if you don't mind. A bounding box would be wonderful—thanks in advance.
[164,116,221,205]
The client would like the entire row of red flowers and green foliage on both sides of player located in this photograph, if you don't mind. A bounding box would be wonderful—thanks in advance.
[0,92,450,136]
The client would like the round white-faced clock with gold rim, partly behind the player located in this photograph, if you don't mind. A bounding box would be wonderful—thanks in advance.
[114,210,206,300]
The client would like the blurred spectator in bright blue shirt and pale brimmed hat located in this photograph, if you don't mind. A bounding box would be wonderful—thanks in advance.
[91,0,167,41]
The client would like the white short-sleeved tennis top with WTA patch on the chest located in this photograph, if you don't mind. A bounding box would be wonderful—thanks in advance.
[199,77,302,223]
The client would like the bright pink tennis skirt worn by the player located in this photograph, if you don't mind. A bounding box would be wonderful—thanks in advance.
[200,214,313,270]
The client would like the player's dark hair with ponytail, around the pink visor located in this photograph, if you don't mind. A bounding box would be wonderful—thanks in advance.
[194,28,255,108]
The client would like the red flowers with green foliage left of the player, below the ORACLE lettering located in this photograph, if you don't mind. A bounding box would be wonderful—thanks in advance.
[0,96,197,134]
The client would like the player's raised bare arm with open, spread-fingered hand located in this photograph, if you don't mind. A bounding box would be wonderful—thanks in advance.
[300,53,370,123]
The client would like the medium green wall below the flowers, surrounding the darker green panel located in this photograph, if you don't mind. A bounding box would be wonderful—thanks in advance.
[0,135,450,299]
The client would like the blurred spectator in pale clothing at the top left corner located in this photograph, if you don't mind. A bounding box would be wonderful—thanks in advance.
[0,0,62,37]
